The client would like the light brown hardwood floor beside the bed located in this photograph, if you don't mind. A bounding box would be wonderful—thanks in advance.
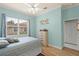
[42,47,79,56]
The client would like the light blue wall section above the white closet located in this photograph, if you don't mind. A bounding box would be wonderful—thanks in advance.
[63,6,79,20]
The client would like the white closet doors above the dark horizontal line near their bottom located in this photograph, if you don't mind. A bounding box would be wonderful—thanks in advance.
[64,21,77,44]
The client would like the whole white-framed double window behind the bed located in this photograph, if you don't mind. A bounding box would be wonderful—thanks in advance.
[6,17,29,36]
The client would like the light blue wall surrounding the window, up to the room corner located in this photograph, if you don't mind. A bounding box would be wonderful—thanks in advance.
[0,8,36,37]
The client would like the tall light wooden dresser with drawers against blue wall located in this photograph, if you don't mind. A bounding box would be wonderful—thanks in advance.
[40,29,48,46]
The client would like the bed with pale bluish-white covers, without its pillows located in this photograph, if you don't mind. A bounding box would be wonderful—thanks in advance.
[0,37,41,56]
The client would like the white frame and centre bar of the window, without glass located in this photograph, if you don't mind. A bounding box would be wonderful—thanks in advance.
[6,16,30,37]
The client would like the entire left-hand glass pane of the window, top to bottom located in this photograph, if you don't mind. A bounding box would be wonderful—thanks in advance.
[6,17,18,35]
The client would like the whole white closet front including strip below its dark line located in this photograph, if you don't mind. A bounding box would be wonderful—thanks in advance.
[64,20,77,48]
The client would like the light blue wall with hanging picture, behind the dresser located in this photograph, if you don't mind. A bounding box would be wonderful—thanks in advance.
[37,7,63,48]
